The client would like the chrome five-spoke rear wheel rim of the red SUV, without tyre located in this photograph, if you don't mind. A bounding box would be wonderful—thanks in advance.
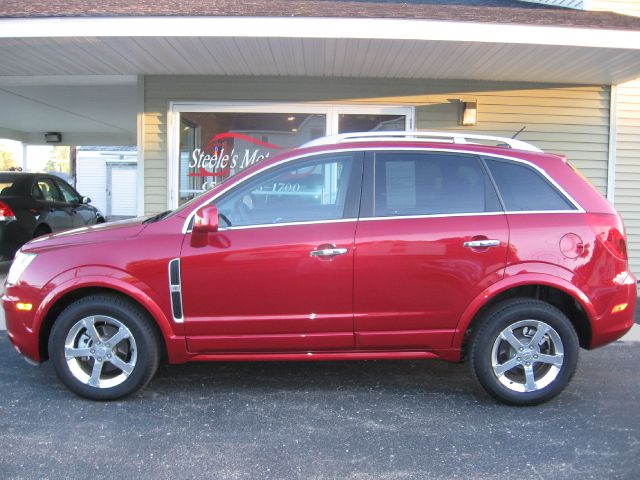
[491,320,564,392]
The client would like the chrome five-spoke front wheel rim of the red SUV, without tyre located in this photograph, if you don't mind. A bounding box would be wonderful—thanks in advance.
[64,315,138,388]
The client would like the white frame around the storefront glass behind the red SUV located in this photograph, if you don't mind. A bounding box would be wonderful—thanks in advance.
[167,101,415,209]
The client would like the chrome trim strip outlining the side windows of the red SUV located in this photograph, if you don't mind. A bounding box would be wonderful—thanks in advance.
[182,146,585,233]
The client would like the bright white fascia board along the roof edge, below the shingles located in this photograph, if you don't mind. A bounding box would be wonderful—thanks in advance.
[0,17,640,50]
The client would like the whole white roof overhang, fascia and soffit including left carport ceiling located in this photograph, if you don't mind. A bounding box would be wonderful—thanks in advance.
[0,17,640,145]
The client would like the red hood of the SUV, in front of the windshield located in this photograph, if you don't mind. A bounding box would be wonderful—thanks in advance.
[22,217,147,253]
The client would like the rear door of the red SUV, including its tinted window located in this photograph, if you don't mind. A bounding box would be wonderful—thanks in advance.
[354,151,509,350]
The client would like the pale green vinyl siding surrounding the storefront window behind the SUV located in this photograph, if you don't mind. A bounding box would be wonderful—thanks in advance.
[144,75,610,213]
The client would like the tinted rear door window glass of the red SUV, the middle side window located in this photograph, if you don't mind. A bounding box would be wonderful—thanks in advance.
[374,152,500,216]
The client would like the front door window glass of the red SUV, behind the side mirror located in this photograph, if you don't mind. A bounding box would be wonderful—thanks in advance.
[215,153,354,227]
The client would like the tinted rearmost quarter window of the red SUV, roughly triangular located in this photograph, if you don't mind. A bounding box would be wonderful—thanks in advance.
[485,159,575,212]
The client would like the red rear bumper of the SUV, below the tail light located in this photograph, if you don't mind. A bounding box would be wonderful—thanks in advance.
[590,272,638,348]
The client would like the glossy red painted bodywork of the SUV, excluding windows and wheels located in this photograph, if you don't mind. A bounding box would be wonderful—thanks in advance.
[3,141,636,363]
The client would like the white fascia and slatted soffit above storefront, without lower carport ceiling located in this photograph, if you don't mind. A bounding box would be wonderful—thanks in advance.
[0,17,640,84]
